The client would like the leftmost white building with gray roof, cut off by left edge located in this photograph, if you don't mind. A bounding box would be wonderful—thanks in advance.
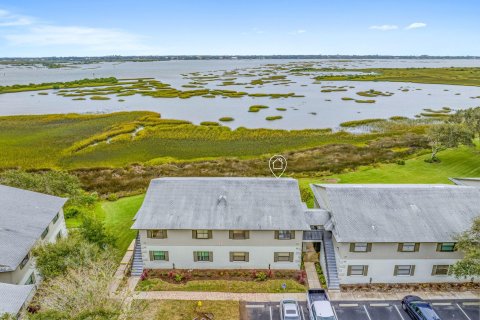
[0,185,67,285]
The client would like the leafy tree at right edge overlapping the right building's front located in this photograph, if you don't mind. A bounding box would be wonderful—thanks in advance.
[451,217,480,278]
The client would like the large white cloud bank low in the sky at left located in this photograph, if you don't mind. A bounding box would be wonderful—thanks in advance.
[0,10,163,54]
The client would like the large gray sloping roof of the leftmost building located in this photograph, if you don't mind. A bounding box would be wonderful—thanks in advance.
[0,185,67,272]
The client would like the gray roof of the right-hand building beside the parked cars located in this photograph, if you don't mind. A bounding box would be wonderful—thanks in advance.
[312,184,480,242]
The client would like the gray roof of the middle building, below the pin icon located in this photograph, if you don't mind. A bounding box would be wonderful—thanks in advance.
[132,178,310,230]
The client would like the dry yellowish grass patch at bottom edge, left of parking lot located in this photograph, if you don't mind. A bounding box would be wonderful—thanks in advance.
[138,300,240,320]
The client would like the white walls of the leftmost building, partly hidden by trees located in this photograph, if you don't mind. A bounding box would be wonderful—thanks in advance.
[0,210,68,284]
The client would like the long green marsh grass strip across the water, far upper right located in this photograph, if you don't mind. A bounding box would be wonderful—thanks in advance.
[315,68,480,86]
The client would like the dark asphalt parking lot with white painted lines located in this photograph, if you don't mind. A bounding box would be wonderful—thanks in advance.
[241,300,480,320]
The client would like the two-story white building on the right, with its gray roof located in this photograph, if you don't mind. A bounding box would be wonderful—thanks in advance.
[311,184,480,288]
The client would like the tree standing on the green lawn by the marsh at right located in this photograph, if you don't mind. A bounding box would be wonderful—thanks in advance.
[427,123,474,162]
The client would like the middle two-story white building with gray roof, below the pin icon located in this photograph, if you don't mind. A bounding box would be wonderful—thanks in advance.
[132,178,310,274]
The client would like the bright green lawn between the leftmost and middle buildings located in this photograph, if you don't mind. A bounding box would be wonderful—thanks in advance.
[67,194,145,253]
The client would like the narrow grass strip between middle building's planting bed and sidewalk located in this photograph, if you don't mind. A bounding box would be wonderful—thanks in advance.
[136,279,306,293]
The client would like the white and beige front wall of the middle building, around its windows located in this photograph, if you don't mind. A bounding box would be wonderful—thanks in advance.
[140,230,302,269]
